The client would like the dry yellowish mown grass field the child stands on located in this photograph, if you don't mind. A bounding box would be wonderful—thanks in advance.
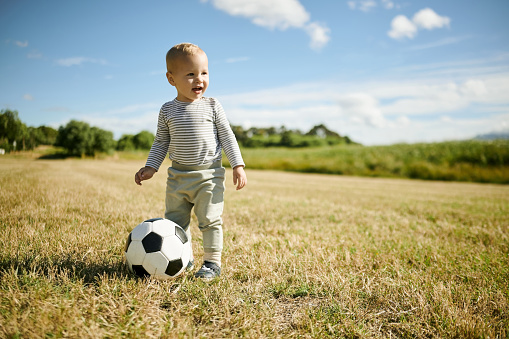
[0,157,509,338]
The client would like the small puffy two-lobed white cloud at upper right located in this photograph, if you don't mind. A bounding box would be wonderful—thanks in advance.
[387,8,451,39]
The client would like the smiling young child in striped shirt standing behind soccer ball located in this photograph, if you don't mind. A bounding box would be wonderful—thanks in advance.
[134,43,247,280]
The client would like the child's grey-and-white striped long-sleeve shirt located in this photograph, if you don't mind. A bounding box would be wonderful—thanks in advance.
[146,97,244,170]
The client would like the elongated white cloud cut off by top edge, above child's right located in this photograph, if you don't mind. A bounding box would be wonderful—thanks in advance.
[202,0,330,49]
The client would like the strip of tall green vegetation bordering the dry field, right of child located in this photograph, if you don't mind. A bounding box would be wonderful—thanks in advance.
[238,140,509,184]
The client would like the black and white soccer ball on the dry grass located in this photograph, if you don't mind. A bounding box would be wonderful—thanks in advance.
[125,218,191,279]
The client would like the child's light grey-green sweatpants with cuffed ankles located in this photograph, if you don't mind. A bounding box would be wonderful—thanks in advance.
[164,161,225,253]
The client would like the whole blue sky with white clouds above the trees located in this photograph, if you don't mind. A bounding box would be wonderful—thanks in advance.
[0,0,509,145]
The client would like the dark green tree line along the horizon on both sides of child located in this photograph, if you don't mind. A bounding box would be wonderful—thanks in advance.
[0,109,357,157]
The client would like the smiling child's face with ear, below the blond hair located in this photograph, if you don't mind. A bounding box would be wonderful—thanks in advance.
[166,53,209,102]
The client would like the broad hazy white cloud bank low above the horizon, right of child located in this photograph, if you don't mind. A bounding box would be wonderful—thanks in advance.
[214,55,509,145]
